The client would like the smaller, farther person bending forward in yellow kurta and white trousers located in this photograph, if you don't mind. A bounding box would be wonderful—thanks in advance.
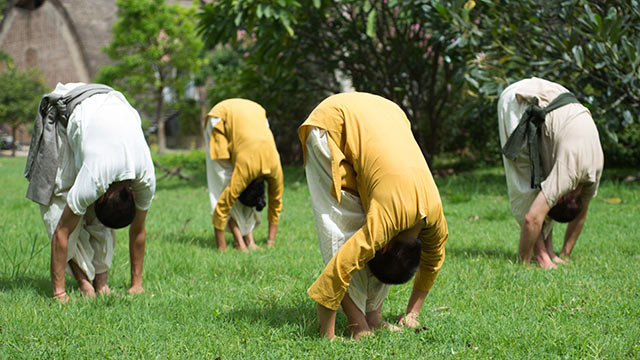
[205,99,283,252]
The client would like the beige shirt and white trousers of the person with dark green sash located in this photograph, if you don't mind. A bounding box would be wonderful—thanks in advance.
[498,78,604,229]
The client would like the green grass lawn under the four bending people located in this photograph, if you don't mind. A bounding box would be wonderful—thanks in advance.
[0,154,640,359]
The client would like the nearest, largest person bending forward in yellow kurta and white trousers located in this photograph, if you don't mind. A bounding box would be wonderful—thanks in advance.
[298,92,448,338]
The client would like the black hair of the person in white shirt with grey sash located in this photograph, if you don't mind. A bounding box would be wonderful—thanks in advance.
[94,187,136,229]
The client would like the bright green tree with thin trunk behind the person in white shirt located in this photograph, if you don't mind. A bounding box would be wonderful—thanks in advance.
[97,0,202,152]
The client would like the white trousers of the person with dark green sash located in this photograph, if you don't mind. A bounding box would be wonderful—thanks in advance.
[498,86,553,238]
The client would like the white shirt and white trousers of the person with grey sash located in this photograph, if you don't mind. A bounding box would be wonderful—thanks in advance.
[40,83,155,280]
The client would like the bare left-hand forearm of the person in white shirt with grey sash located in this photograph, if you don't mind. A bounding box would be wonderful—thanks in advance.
[50,205,81,295]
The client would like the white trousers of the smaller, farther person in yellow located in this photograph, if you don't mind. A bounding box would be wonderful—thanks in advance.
[204,117,260,236]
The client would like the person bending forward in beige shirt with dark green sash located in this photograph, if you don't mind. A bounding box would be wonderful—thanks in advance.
[498,78,604,268]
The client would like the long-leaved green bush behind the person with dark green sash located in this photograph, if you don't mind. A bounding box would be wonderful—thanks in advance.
[468,0,640,165]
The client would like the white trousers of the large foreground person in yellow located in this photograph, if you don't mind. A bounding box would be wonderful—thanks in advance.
[305,128,390,314]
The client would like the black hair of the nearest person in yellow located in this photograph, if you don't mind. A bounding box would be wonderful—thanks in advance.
[367,239,422,284]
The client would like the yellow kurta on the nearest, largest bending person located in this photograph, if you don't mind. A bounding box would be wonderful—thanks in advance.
[298,92,449,310]
